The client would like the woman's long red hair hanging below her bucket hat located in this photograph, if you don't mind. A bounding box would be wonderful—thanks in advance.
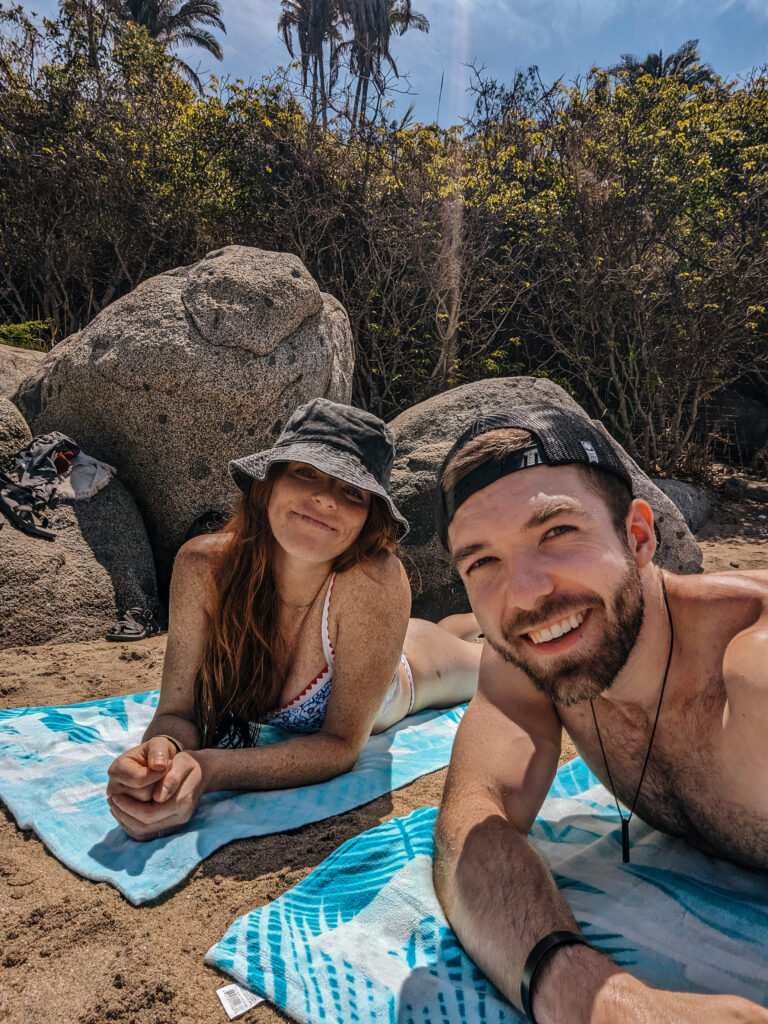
[195,464,396,746]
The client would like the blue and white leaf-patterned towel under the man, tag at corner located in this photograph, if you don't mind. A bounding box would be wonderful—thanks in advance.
[207,760,768,1024]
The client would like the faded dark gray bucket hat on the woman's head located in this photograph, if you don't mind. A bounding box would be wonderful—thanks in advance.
[229,398,409,538]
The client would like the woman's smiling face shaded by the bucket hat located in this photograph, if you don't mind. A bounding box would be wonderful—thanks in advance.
[267,462,371,561]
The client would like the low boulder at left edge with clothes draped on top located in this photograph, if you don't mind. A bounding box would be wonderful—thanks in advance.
[0,480,163,643]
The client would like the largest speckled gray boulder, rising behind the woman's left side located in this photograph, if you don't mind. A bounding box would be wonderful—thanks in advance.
[14,246,354,584]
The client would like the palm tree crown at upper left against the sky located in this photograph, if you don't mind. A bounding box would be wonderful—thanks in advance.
[109,0,226,92]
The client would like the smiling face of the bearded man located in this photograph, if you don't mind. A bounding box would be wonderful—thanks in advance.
[449,466,643,707]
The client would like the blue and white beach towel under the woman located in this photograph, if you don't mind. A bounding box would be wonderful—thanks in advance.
[0,691,464,903]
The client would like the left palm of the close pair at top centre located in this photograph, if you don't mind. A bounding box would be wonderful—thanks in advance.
[278,0,342,124]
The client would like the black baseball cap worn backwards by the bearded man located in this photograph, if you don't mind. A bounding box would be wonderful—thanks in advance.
[435,403,632,547]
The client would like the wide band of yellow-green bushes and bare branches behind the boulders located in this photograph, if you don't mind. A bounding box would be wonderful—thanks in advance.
[0,3,768,468]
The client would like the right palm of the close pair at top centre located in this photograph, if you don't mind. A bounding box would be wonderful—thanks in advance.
[341,0,429,127]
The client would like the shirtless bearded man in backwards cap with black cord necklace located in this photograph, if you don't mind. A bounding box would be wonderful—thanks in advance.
[434,406,768,1024]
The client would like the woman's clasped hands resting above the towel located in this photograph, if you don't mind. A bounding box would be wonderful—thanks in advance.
[106,736,206,841]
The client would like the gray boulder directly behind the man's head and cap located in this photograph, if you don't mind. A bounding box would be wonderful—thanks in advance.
[388,377,701,621]
